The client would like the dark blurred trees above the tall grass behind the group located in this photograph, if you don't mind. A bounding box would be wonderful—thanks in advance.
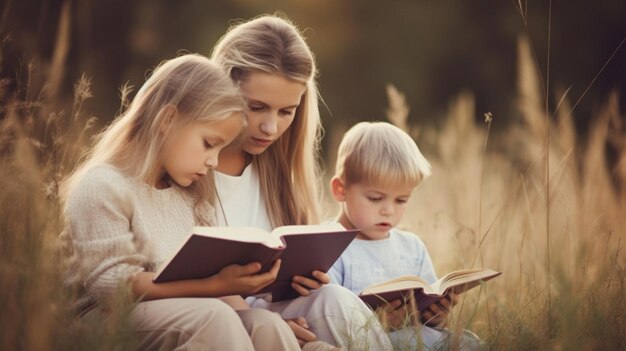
[0,0,626,139]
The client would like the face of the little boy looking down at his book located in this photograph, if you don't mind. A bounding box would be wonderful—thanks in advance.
[332,178,415,240]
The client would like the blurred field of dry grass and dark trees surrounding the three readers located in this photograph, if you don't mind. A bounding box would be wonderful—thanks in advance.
[0,0,626,350]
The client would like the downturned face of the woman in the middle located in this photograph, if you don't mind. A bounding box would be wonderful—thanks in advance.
[236,71,306,155]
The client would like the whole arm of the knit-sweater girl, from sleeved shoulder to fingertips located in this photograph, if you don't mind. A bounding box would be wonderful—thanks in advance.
[66,167,280,303]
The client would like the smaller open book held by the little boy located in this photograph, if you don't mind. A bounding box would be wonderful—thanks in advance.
[359,269,502,312]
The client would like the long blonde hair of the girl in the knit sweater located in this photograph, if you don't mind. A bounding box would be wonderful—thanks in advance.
[61,54,245,224]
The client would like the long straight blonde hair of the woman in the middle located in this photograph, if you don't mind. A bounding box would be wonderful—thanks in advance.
[211,15,321,227]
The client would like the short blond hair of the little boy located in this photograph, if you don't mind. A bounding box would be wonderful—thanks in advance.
[335,122,430,187]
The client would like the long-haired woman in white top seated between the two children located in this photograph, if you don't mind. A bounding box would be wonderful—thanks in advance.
[212,16,391,350]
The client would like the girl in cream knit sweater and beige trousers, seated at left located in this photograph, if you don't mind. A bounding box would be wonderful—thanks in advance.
[62,55,298,350]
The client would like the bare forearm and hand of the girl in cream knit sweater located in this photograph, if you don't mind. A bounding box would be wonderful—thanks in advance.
[130,260,280,301]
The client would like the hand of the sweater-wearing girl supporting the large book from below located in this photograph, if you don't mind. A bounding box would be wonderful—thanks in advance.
[214,259,280,295]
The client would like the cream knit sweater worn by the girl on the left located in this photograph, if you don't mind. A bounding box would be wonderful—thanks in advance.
[65,165,195,312]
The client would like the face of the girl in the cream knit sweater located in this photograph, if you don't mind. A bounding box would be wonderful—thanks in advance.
[162,115,242,187]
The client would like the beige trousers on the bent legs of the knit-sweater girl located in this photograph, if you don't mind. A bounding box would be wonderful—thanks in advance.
[131,298,300,351]
